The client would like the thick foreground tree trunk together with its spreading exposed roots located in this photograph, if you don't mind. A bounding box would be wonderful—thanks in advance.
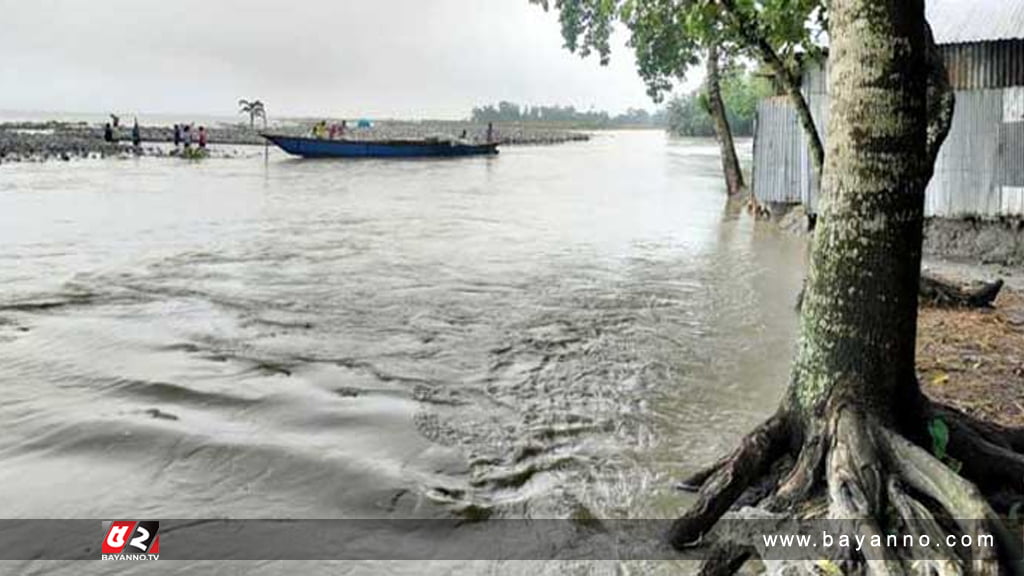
[670,0,1024,574]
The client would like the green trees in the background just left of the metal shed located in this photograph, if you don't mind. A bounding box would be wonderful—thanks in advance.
[667,67,773,136]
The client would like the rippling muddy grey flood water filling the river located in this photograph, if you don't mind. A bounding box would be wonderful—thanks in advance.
[0,132,803,574]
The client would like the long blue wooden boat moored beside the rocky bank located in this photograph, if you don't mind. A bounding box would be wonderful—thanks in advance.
[256,134,498,158]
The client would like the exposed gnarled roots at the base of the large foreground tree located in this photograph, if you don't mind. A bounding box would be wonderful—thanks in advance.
[669,405,1024,575]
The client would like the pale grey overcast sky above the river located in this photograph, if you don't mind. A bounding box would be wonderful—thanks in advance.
[0,0,696,118]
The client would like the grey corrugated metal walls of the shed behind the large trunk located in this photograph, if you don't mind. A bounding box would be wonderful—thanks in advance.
[754,42,1024,217]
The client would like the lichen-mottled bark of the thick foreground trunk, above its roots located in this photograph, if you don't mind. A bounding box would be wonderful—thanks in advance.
[791,0,931,416]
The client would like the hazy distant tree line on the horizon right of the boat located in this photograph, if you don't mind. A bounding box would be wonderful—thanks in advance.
[472,101,668,128]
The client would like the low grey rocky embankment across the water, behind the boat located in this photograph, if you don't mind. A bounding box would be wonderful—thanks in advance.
[0,121,590,163]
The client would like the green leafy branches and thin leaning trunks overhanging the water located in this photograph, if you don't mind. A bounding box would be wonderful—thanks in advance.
[530,0,829,195]
